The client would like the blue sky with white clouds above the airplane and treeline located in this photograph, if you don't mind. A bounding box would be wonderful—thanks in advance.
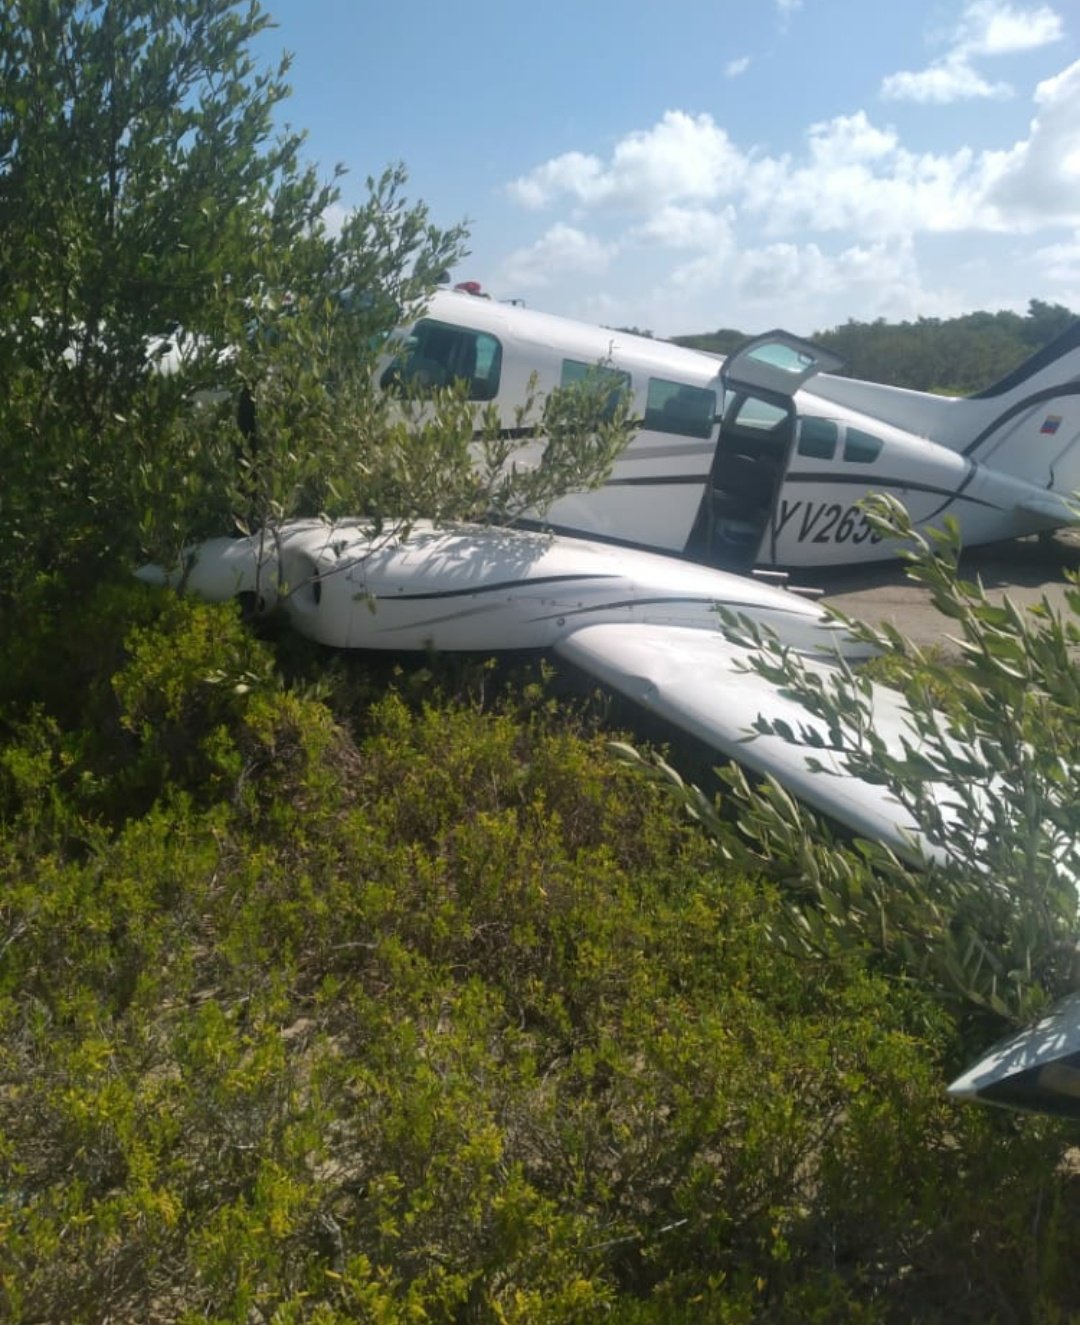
[257,0,1080,335]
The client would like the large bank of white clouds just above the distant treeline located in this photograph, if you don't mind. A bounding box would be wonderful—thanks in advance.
[504,43,1080,333]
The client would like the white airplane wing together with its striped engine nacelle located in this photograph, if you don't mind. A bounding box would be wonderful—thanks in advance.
[139,521,946,863]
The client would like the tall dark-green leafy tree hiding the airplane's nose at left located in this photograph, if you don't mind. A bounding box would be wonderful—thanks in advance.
[0,0,625,610]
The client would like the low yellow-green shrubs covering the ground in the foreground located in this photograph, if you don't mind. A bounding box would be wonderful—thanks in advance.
[0,590,1080,1322]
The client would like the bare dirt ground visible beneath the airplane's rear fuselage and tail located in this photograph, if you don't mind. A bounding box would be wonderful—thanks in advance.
[810,530,1080,644]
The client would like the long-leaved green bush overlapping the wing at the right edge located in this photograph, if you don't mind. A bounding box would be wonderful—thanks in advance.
[704,498,1080,1037]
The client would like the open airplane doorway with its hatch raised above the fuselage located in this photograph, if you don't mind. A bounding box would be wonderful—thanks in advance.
[701,331,843,568]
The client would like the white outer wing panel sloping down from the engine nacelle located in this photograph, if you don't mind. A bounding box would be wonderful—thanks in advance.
[555,623,928,863]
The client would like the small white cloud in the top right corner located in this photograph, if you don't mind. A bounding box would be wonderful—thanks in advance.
[881,0,1064,105]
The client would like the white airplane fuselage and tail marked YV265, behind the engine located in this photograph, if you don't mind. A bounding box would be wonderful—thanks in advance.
[382,282,1080,568]
